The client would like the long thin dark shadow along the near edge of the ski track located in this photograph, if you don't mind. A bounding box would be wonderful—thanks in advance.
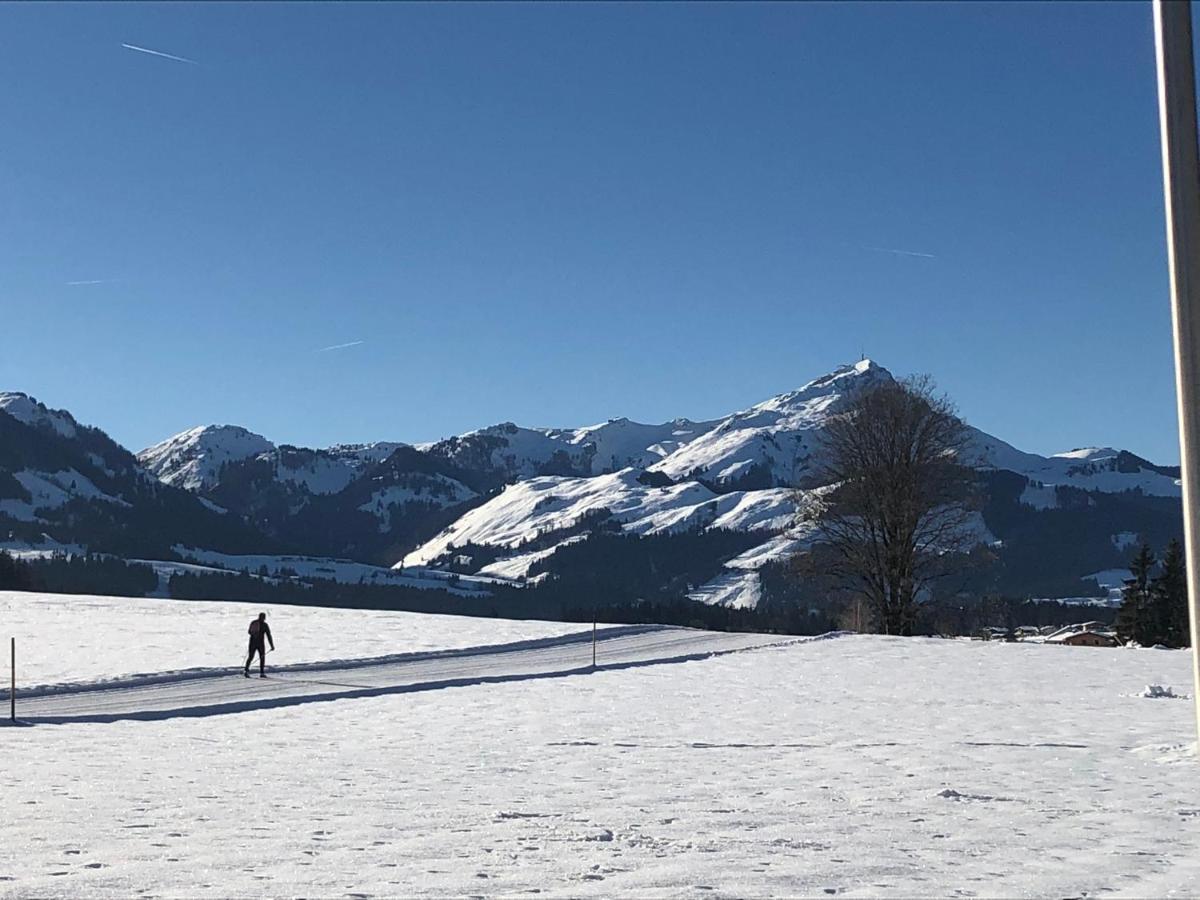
[19,644,748,725]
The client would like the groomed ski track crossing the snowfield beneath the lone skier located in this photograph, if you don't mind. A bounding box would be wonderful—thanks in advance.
[18,625,814,725]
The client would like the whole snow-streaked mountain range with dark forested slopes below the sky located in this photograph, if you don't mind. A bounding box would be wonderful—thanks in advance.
[0,360,1182,607]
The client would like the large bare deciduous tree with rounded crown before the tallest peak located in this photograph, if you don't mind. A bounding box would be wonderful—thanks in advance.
[820,377,974,635]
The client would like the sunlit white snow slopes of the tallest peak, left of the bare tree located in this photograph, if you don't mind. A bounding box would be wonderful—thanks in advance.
[398,360,1008,607]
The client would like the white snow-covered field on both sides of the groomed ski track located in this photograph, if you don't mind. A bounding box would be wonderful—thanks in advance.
[0,595,1200,896]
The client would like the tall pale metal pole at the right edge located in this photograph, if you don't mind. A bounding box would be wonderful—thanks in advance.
[1154,0,1200,753]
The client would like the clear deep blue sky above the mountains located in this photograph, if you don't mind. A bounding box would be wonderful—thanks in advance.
[0,4,1178,462]
